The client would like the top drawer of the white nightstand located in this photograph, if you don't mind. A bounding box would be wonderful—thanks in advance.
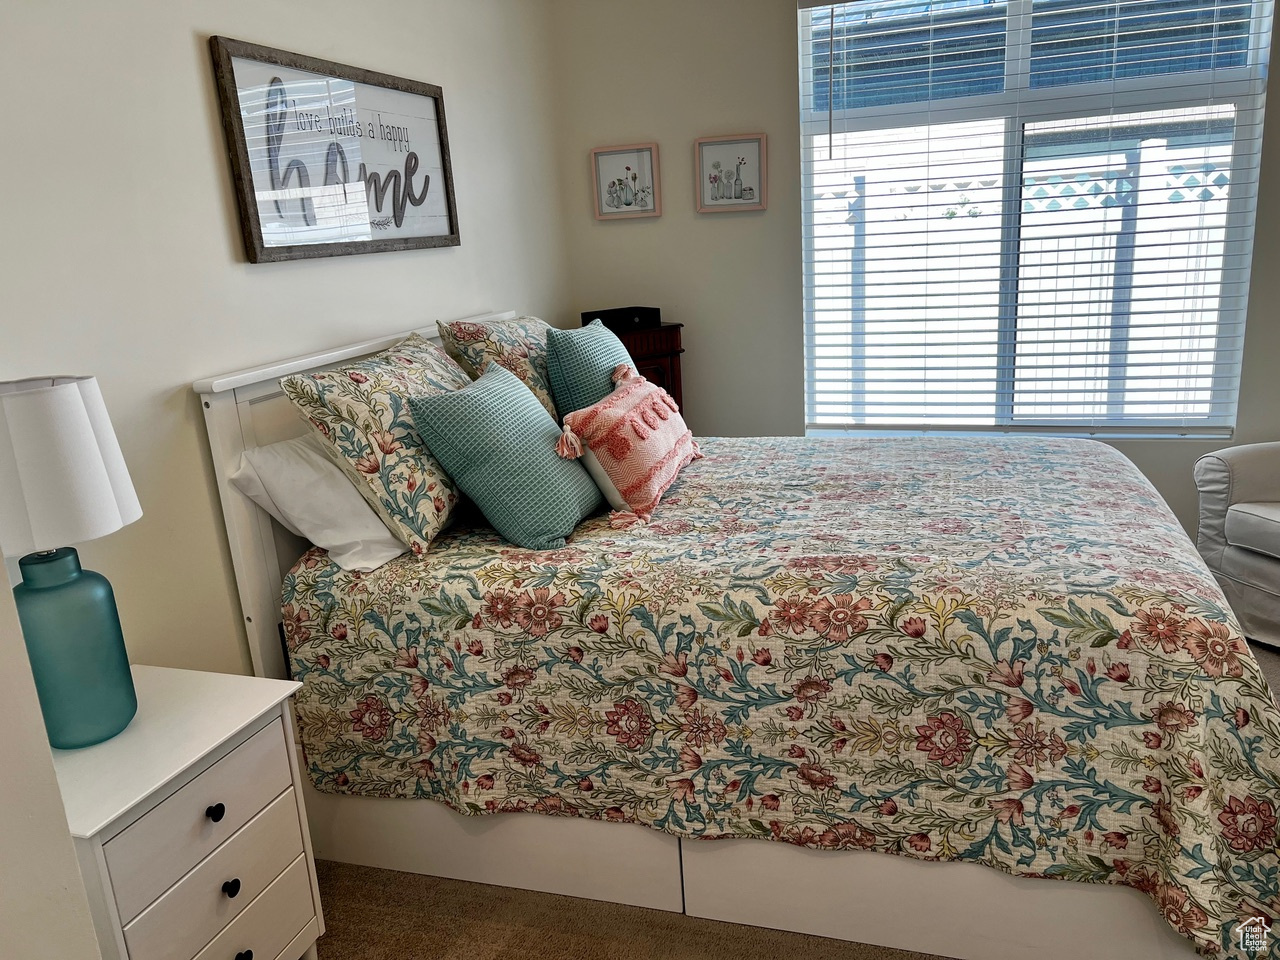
[102,719,292,923]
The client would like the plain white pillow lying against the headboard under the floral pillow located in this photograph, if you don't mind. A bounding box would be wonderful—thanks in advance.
[230,433,408,572]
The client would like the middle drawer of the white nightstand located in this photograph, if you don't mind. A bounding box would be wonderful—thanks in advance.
[124,788,302,960]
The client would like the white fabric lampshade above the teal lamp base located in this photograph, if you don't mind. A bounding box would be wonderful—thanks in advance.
[0,376,142,557]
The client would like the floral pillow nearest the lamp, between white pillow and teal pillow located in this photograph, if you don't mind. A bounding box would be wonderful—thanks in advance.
[280,334,471,554]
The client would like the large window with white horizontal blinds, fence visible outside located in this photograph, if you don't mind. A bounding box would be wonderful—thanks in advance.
[800,0,1272,436]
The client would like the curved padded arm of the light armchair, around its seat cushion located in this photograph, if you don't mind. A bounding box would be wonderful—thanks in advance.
[1194,443,1280,570]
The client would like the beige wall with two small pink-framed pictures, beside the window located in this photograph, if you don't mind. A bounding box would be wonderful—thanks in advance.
[554,0,804,435]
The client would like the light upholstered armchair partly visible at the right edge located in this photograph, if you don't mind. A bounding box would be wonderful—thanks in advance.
[1196,443,1280,646]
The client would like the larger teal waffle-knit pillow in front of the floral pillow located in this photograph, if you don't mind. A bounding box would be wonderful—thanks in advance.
[408,364,603,550]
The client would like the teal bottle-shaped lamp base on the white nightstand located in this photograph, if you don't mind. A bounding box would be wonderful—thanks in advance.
[13,547,138,750]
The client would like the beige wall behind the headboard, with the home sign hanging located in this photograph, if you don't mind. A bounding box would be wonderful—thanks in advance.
[0,0,566,672]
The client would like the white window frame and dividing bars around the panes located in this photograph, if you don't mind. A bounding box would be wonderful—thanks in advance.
[799,0,1272,439]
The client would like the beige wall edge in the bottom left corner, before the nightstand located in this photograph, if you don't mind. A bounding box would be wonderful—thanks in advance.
[0,586,100,960]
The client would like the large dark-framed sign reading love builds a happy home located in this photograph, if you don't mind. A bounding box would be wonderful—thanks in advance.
[209,37,460,264]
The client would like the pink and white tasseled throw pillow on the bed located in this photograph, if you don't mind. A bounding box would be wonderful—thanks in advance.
[556,364,703,520]
